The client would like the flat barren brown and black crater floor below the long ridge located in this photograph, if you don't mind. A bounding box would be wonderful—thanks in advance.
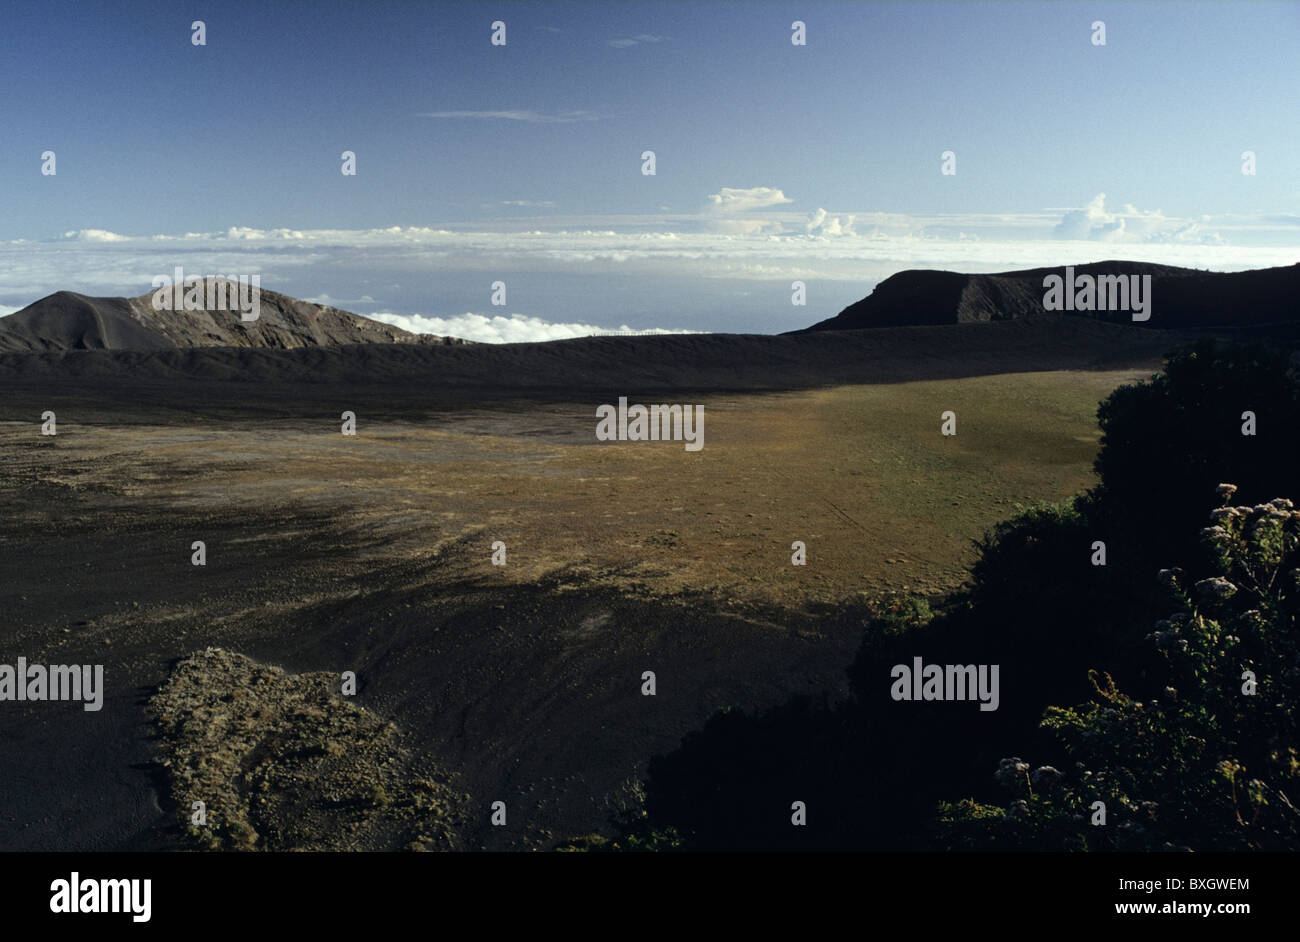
[0,358,1149,850]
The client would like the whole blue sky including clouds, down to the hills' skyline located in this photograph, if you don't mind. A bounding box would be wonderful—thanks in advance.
[0,0,1300,339]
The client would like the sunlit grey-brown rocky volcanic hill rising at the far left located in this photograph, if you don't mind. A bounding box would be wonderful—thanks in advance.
[0,283,464,353]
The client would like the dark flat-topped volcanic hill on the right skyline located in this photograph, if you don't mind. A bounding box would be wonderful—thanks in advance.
[796,261,1300,333]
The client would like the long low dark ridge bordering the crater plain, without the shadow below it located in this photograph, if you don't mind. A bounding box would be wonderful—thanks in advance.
[0,316,1177,392]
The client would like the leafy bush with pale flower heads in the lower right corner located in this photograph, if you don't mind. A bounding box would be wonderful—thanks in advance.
[939,485,1300,851]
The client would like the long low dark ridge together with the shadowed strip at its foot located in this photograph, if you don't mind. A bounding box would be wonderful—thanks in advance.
[0,316,1237,421]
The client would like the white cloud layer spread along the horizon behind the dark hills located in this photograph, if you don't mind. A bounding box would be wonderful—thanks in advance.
[0,186,1300,340]
